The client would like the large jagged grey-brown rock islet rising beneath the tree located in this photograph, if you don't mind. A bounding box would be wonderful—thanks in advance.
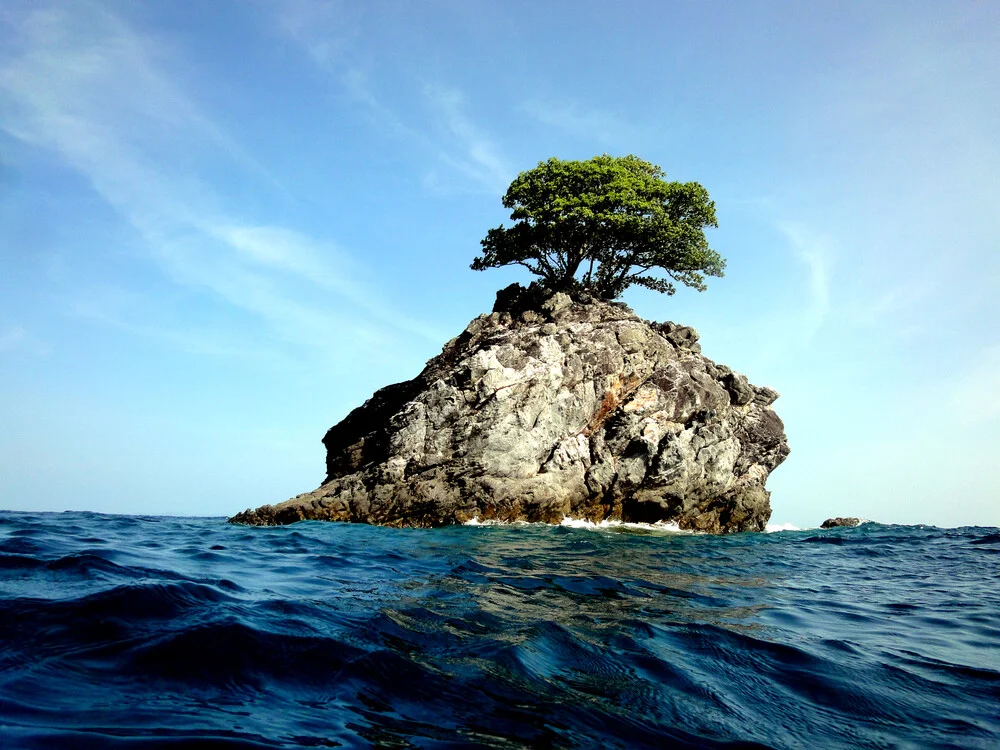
[231,285,789,533]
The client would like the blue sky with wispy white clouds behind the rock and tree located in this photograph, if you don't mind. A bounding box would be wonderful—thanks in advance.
[0,0,1000,526]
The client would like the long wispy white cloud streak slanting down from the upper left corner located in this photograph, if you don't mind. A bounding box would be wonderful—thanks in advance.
[0,3,437,356]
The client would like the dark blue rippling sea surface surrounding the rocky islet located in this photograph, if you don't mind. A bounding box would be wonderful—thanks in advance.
[0,512,1000,749]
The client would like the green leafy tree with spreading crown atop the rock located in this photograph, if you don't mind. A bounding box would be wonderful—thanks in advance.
[472,154,726,299]
